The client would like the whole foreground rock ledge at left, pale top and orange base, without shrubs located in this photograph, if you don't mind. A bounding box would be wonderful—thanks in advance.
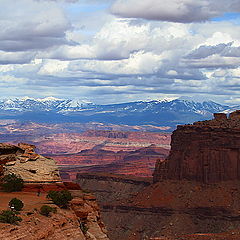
[0,143,109,240]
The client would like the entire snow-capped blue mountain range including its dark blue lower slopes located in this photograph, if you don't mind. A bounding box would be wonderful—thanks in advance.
[0,97,234,126]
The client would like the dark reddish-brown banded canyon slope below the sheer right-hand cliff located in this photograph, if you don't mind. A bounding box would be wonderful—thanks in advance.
[77,173,240,240]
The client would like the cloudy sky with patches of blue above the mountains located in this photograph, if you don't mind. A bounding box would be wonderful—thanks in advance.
[0,0,240,105]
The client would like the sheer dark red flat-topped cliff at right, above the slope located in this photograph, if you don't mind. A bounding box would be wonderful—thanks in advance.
[153,111,240,183]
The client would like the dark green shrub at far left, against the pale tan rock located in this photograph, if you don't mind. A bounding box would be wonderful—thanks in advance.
[2,173,23,192]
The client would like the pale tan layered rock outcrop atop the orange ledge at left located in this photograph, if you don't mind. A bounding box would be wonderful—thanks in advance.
[0,143,61,182]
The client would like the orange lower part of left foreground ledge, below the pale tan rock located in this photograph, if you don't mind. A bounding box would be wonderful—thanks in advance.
[0,189,109,240]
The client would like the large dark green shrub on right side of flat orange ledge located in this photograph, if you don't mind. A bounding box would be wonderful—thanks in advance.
[47,190,73,208]
